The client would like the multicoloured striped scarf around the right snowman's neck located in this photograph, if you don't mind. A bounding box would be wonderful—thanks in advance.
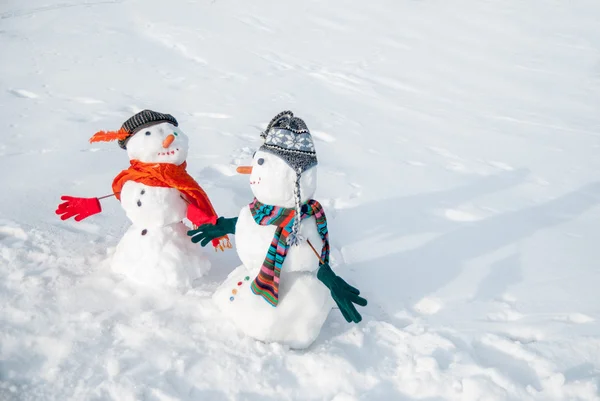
[250,198,329,306]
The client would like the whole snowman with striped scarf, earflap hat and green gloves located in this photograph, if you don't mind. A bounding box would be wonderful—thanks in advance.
[188,111,367,349]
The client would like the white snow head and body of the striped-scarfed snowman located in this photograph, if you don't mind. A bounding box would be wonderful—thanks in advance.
[213,151,333,349]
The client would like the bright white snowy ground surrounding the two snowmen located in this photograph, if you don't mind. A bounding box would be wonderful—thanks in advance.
[0,0,600,401]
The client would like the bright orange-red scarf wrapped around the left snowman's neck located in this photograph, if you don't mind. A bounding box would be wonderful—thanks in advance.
[113,160,231,250]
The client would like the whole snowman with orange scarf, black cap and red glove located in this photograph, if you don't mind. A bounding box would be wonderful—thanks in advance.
[56,110,231,289]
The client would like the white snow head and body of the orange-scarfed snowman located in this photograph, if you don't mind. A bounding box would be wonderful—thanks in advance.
[111,123,210,289]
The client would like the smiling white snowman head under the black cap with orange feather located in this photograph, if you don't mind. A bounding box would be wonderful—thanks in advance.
[126,122,188,165]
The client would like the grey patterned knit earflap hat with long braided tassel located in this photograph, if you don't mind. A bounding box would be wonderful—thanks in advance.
[258,110,318,245]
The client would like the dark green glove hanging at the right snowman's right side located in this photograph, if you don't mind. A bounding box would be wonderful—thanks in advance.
[317,265,367,323]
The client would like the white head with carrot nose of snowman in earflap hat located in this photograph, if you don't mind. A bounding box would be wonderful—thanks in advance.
[243,150,317,208]
